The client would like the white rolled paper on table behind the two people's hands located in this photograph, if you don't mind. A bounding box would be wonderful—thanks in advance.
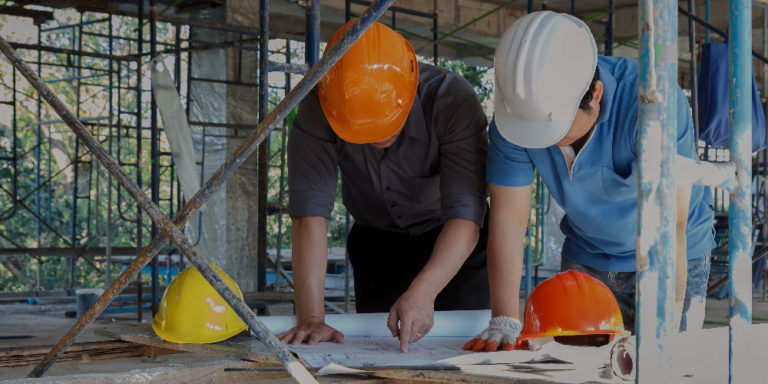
[259,309,491,336]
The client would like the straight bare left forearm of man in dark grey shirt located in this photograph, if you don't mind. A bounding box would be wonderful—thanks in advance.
[291,217,328,323]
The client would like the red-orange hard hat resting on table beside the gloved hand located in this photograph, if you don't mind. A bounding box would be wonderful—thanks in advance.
[517,270,628,349]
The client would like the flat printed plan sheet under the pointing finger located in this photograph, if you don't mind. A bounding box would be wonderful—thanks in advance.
[288,336,472,368]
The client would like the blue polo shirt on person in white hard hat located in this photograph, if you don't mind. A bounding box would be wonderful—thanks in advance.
[486,56,715,272]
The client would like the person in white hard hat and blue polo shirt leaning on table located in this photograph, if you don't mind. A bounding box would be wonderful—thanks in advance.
[465,12,714,351]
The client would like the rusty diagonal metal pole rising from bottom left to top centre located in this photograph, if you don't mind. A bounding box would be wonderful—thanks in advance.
[6,0,394,377]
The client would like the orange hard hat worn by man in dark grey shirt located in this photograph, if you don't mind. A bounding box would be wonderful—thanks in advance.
[319,19,419,144]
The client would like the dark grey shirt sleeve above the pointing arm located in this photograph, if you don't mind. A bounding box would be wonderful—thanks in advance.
[433,75,488,225]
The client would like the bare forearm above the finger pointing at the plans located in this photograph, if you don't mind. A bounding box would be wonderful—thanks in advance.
[409,219,479,301]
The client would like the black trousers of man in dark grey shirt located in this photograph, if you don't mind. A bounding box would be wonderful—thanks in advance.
[347,219,491,313]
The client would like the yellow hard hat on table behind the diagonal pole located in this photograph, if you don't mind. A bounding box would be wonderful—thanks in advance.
[152,264,248,344]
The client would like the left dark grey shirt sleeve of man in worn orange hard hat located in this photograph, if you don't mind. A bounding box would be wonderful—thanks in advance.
[288,89,338,218]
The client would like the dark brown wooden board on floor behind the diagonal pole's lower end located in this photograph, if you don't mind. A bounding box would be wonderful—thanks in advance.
[0,340,178,367]
